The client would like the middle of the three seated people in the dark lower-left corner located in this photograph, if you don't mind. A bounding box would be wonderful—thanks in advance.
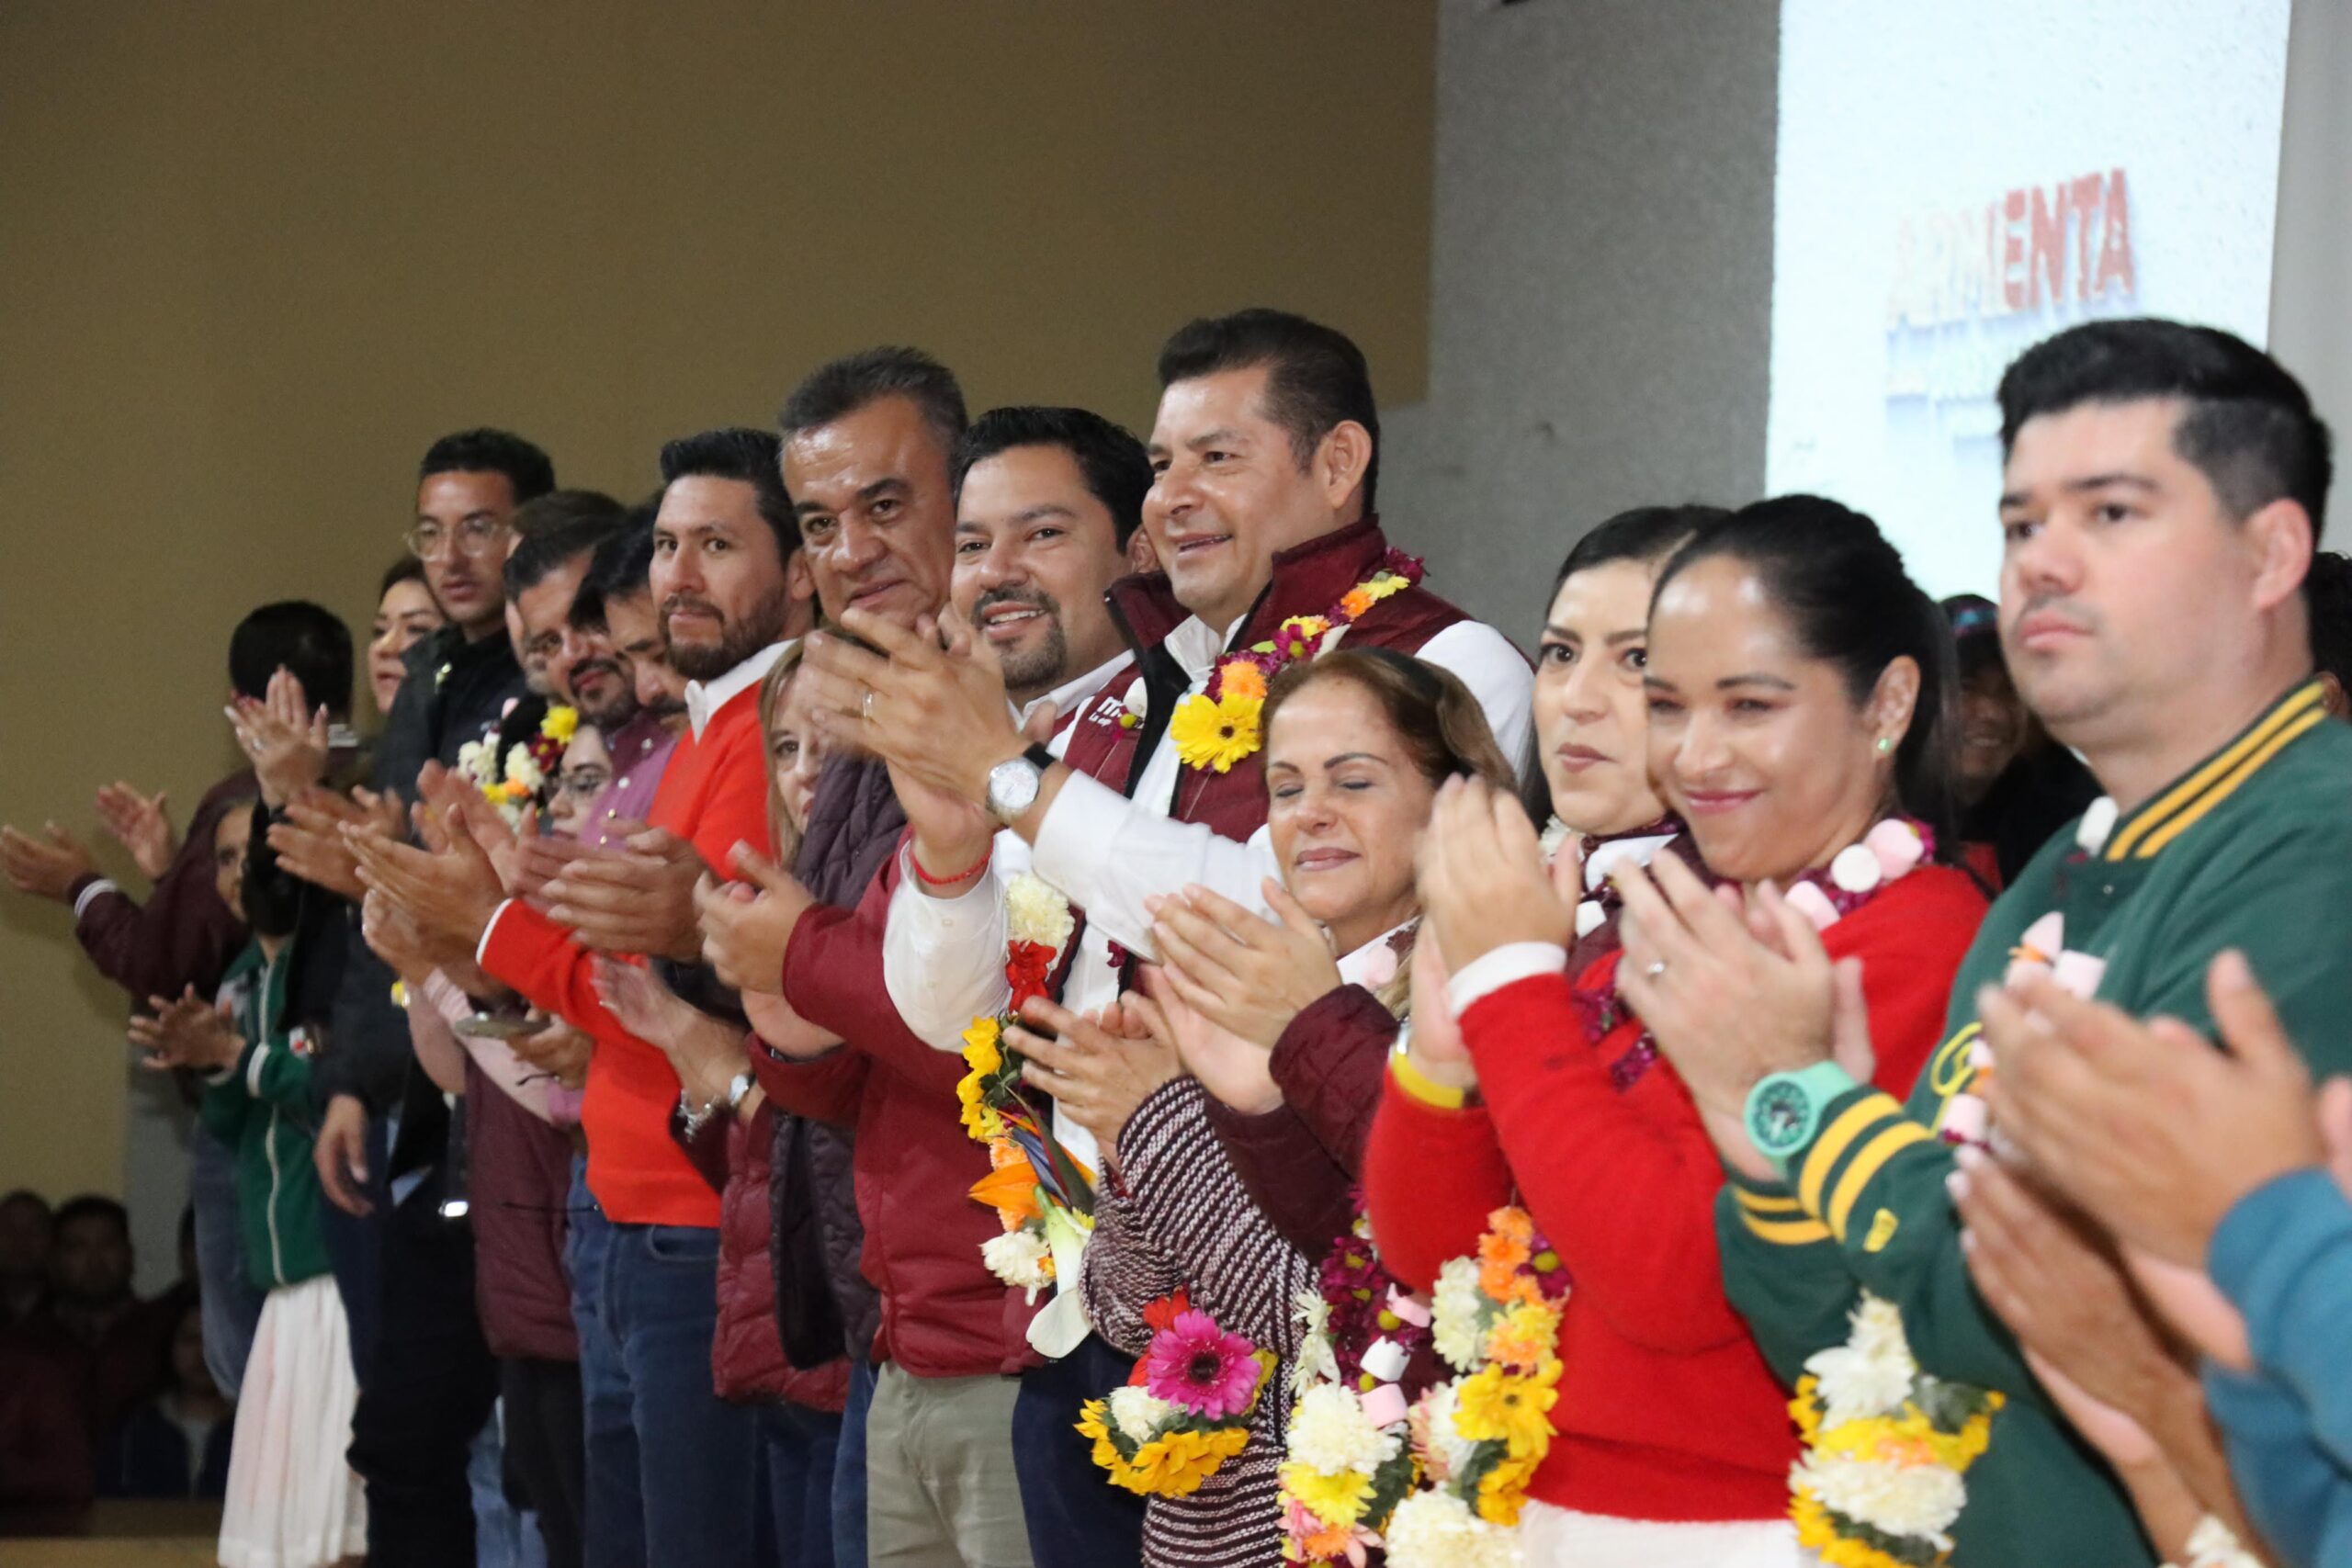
[12,1194,176,1485]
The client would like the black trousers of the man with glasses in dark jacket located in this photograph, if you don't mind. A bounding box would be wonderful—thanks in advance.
[350,1190,499,1568]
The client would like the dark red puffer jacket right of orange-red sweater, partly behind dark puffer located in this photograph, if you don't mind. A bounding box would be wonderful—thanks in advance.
[710,1102,849,1413]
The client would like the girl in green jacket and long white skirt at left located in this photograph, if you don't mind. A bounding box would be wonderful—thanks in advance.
[131,799,367,1568]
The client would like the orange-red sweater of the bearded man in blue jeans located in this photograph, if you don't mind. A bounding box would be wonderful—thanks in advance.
[482,684,772,1227]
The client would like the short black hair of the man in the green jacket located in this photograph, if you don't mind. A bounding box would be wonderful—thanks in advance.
[2002,317,2335,541]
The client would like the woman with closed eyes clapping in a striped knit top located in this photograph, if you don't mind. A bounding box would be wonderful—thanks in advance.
[1025,649,1510,1563]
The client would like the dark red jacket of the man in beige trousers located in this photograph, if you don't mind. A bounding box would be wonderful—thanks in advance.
[752,856,1028,1378]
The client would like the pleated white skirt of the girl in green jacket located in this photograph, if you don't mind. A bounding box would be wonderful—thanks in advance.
[221,1274,367,1568]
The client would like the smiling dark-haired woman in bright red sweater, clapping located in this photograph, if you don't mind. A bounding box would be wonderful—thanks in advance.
[1366,496,1983,1568]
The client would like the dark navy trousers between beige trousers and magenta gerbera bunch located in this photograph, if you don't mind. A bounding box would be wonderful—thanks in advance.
[1013,1336,1143,1568]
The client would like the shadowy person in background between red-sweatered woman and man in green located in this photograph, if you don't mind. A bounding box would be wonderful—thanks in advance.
[1943,592,2098,891]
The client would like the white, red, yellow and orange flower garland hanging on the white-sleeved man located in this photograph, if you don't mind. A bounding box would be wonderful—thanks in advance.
[955,872,1093,1300]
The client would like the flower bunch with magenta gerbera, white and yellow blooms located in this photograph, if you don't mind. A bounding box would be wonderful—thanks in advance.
[1077,1291,1275,1497]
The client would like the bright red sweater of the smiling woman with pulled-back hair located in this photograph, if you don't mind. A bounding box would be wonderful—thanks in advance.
[1364,867,1985,1521]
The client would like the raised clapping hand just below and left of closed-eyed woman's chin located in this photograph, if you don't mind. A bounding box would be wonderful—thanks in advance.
[1146,877,1340,1051]
